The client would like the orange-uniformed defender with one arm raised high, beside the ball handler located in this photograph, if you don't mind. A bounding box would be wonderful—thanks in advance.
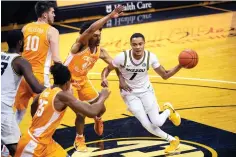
[65,6,123,151]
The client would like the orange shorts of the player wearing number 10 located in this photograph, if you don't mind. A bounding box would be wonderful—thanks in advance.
[14,73,50,110]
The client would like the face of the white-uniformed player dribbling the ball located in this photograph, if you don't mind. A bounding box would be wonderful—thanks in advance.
[130,37,145,56]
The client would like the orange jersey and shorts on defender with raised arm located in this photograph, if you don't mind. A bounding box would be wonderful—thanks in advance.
[64,46,100,102]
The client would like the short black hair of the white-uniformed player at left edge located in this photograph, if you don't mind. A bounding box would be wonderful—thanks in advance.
[7,30,24,48]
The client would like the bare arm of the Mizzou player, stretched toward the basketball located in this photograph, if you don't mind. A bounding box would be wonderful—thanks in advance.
[154,65,182,80]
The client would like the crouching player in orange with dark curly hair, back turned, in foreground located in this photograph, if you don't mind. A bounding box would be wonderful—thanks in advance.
[15,63,110,157]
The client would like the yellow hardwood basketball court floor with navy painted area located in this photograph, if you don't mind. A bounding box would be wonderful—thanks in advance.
[2,2,236,157]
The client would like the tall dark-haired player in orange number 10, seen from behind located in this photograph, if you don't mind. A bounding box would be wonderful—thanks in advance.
[15,1,61,123]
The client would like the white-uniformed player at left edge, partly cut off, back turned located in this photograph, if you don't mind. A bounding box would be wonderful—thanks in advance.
[1,30,44,156]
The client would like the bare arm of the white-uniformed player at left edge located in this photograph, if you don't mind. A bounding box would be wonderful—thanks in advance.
[13,57,45,94]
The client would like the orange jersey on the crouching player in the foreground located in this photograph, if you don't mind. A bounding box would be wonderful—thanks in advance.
[29,87,66,144]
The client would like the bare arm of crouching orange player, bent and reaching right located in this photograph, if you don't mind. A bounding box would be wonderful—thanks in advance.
[57,89,110,118]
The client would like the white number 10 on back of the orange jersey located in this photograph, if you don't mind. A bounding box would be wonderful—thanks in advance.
[25,35,39,51]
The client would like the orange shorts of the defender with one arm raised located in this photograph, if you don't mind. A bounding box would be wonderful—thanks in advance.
[72,80,99,102]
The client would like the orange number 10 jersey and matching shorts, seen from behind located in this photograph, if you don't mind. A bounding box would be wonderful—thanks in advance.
[14,22,52,110]
